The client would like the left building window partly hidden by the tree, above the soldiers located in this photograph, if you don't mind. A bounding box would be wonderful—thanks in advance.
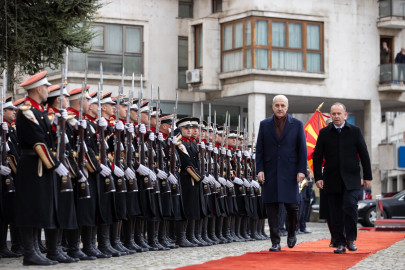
[69,24,143,74]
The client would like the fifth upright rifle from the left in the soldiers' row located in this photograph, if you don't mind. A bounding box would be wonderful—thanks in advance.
[114,68,127,192]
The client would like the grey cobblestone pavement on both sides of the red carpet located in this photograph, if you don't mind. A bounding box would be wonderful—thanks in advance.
[0,223,405,270]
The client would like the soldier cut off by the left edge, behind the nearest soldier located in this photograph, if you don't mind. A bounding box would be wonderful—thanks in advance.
[0,97,24,258]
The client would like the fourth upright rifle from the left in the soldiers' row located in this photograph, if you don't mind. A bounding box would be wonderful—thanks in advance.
[97,63,116,193]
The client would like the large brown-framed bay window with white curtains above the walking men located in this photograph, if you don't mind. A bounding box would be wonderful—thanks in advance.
[222,17,323,72]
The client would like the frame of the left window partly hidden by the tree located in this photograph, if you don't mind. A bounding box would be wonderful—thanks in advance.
[69,23,144,74]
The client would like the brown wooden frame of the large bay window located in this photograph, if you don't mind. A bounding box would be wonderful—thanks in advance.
[221,16,325,73]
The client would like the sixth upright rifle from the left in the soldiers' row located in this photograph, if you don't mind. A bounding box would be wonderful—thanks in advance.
[125,73,138,192]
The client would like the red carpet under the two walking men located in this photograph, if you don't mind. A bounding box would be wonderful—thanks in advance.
[177,232,405,270]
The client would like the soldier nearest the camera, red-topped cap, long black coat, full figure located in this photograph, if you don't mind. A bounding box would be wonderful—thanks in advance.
[15,71,69,265]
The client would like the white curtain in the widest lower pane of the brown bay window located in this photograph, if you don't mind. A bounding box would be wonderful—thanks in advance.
[271,50,303,70]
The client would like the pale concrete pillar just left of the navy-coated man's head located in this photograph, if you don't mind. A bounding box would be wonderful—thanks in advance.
[248,94,266,138]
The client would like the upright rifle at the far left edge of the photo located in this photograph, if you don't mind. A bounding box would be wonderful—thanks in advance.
[0,70,15,193]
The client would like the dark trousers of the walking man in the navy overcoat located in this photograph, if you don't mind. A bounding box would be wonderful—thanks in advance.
[266,203,298,244]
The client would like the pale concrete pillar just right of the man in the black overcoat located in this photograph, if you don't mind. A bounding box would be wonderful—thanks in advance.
[363,97,381,198]
